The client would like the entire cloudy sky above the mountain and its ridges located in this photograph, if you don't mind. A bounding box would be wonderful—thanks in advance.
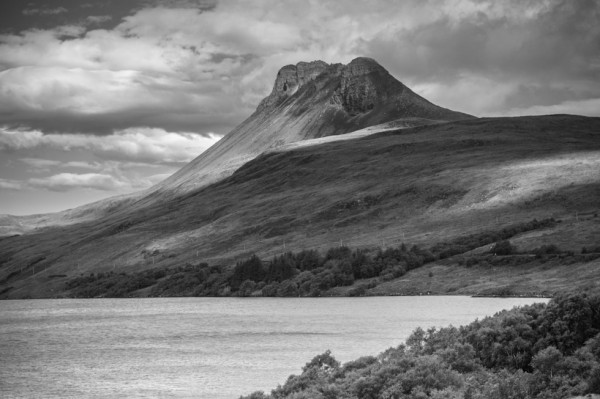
[0,0,600,215]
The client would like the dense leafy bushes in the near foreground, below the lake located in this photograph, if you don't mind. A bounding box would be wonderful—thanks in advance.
[242,295,600,399]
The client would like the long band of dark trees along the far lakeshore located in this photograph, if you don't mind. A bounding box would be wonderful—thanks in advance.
[66,219,600,297]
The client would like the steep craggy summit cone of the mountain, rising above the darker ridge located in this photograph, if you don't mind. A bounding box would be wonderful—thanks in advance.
[153,57,472,195]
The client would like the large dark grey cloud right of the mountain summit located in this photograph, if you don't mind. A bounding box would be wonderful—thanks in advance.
[363,0,600,80]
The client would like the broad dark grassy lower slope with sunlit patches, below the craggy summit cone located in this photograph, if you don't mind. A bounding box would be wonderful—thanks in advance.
[0,115,600,297]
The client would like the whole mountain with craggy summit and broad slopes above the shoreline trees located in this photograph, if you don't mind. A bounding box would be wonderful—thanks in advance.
[0,59,600,298]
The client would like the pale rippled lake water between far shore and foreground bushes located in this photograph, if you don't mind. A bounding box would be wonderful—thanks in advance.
[0,296,545,399]
